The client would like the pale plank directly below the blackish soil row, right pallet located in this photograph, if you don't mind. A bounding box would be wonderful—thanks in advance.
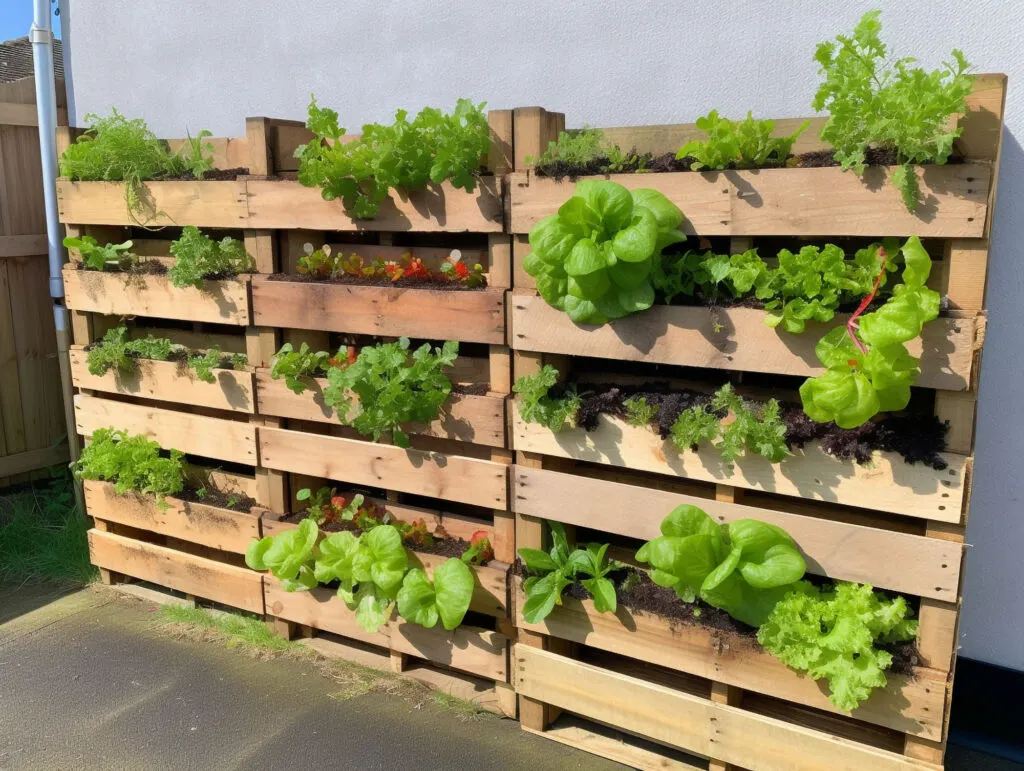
[512,404,968,522]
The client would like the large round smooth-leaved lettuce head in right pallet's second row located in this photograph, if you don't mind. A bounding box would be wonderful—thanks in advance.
[523,179,686,324]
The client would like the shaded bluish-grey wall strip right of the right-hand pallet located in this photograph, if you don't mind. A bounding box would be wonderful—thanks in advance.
[961,123,1024,670]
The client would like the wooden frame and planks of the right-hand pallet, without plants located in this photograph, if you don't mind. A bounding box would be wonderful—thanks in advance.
[508,76,1006,769]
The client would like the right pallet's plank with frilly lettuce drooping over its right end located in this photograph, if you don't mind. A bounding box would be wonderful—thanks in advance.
[515,580,947,740]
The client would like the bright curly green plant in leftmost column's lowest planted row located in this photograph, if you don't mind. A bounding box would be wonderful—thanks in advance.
[72,428,184,502]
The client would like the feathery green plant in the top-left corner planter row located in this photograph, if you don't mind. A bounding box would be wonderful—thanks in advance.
[59,110,213,219]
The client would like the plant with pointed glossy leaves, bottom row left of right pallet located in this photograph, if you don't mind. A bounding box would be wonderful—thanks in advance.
[517,522,624,624]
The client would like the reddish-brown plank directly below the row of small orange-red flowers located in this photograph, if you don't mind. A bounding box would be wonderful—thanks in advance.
[247,276,505,344]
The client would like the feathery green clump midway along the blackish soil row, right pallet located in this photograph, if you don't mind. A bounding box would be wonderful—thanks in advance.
[671,383,790,463]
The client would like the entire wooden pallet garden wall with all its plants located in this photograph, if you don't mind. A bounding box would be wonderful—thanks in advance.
[66,9,1006,769]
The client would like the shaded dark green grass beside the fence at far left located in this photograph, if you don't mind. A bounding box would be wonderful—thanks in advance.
[0,477,98,584]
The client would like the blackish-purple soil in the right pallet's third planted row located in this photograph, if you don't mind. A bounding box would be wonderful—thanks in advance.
[554,383,948,471]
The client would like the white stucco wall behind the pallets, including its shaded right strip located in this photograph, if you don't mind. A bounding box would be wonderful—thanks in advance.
[61,0,1024,669]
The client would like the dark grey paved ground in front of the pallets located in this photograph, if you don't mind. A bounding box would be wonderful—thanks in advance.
[0,588,1020,771]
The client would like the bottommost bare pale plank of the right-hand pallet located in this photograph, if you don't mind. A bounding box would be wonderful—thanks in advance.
[513,645,935,771]
